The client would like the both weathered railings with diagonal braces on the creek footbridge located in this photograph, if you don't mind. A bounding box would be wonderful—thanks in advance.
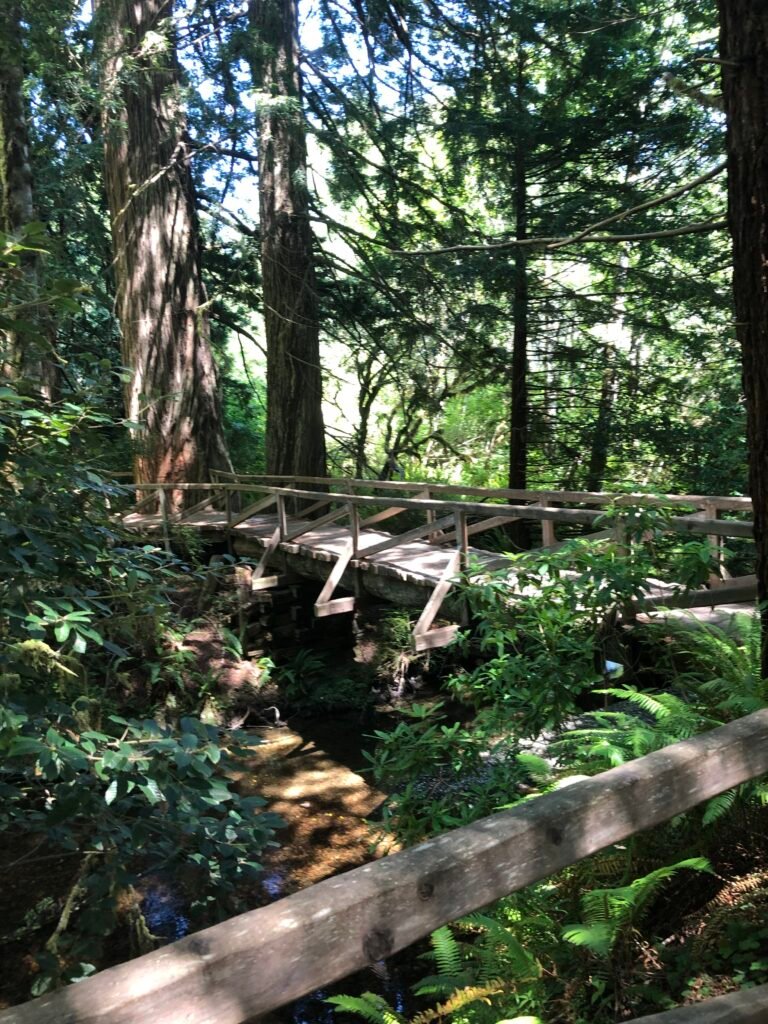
[121,473,756,650]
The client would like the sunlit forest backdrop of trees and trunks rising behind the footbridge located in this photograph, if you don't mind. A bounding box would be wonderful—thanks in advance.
[0,0,745,494]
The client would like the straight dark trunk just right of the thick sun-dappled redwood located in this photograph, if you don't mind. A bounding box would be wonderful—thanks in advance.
[250,0,326,476]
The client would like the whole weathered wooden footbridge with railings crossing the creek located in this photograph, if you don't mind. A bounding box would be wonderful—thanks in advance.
[123,473,756,650]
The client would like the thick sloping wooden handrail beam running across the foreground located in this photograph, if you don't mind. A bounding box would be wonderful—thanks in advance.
[7,711,768,1024]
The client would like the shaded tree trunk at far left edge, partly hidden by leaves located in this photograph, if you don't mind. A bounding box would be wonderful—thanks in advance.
[0,8,58,400]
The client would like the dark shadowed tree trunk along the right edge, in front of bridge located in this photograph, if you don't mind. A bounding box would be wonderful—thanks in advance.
[719,0,768,678]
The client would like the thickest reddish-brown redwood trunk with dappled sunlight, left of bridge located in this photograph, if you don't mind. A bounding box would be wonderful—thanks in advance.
[97,0,231,497]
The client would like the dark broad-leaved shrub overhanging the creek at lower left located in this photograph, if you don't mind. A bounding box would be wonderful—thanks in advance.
[0,693,282,994]
